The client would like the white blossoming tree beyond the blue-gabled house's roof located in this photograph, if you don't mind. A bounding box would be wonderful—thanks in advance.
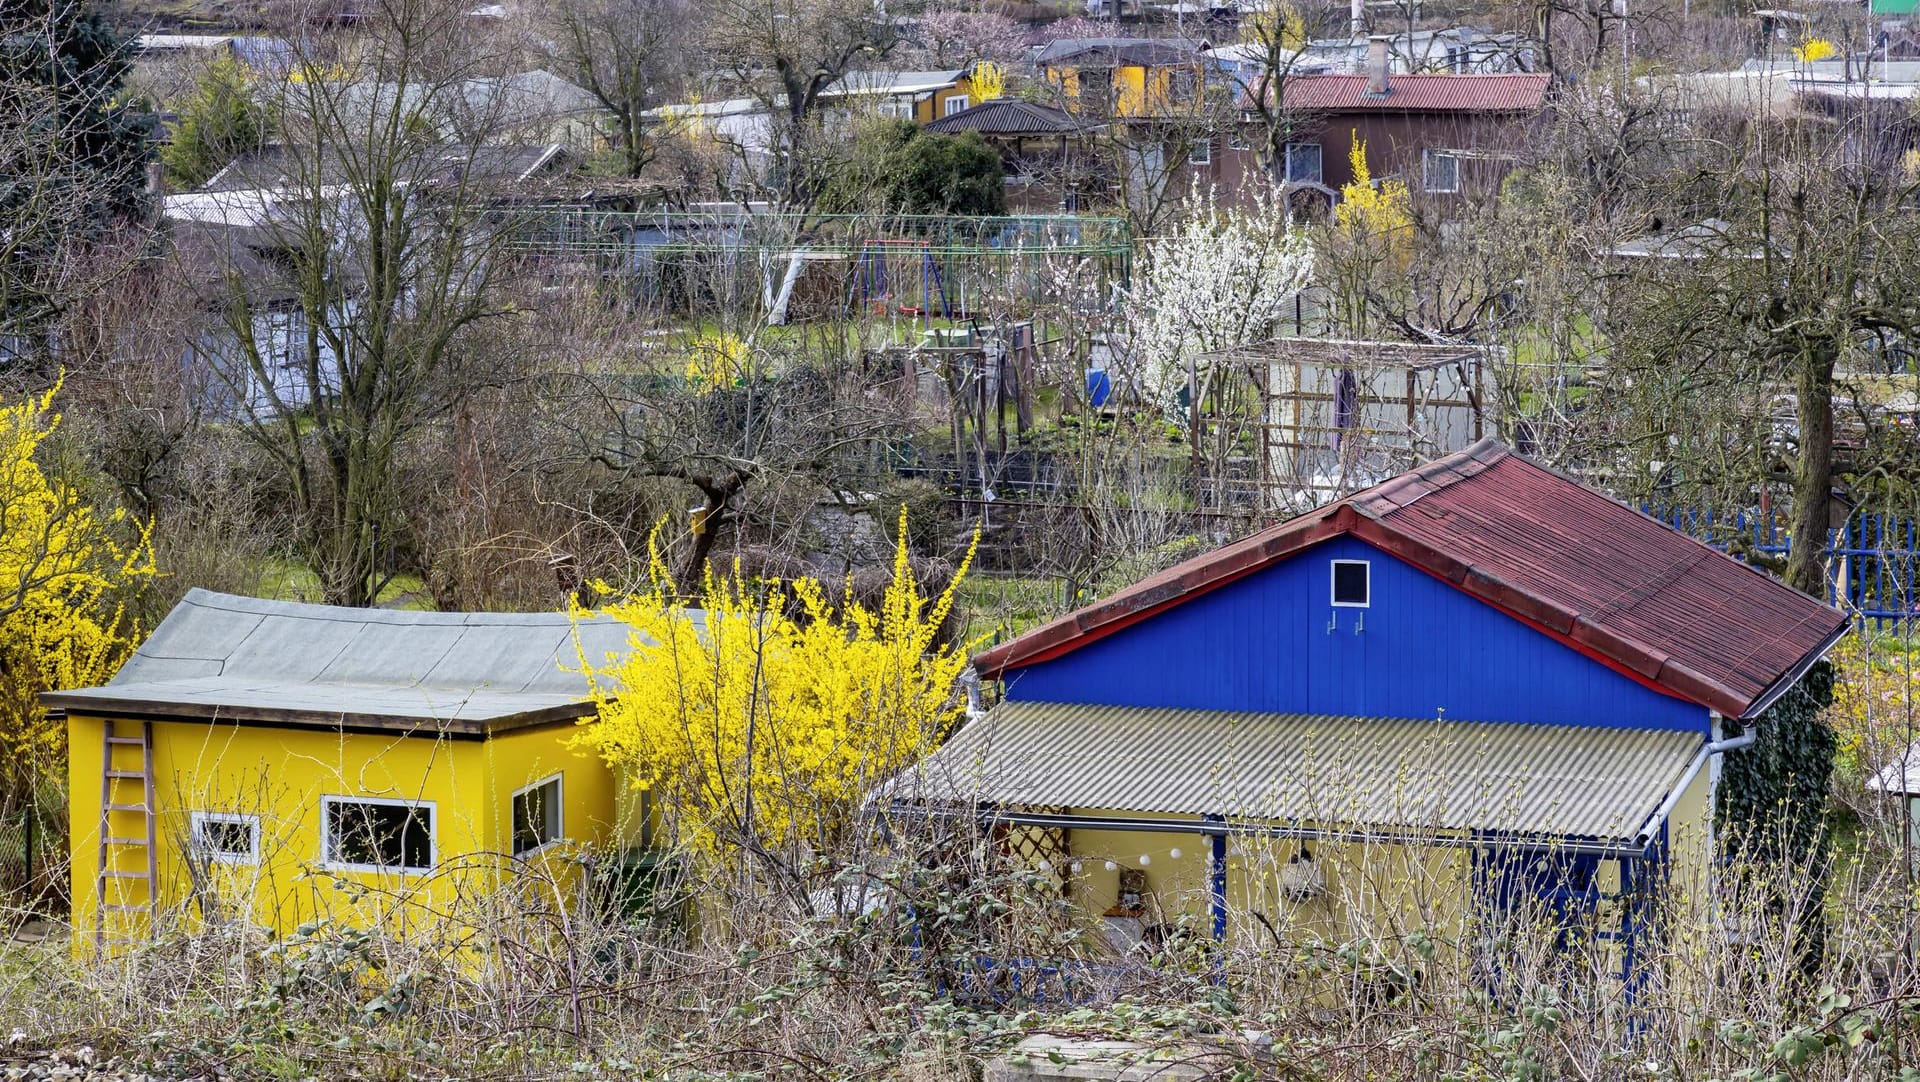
[1127,192,1313,414]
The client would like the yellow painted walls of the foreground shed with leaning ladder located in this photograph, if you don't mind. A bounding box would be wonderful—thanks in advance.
[67,716,616,940]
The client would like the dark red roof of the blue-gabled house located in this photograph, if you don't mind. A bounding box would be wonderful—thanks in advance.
[973,439,1847,717]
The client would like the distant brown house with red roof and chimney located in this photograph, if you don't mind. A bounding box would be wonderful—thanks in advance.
[1236,38,1548,203]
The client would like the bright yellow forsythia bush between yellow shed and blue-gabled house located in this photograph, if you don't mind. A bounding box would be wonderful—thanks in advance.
[574,508,973,859]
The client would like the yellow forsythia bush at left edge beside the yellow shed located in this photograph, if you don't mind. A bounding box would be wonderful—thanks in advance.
[0,391,154,808]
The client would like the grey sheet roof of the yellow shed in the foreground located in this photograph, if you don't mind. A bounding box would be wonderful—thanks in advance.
[42,589,664,735]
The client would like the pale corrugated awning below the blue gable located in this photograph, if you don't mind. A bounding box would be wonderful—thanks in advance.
[891,702,1705,844]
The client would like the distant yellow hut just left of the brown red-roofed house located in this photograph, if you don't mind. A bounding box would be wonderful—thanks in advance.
[1037,38,1208,121]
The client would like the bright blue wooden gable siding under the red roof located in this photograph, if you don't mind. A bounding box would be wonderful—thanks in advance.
[1006,537,1709,733]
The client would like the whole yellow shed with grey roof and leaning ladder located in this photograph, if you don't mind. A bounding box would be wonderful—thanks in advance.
[44,589,643,942]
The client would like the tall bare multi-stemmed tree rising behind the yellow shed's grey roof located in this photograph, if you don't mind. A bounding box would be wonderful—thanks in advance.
[182,0,526,604]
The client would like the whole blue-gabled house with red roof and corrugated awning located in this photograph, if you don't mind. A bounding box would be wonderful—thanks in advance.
[895,439,1849,969]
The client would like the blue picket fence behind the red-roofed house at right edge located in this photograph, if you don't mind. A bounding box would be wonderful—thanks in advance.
[1647,506,1920,622]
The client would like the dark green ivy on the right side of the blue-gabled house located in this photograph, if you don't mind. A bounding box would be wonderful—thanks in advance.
[1713,662,1836,975]
